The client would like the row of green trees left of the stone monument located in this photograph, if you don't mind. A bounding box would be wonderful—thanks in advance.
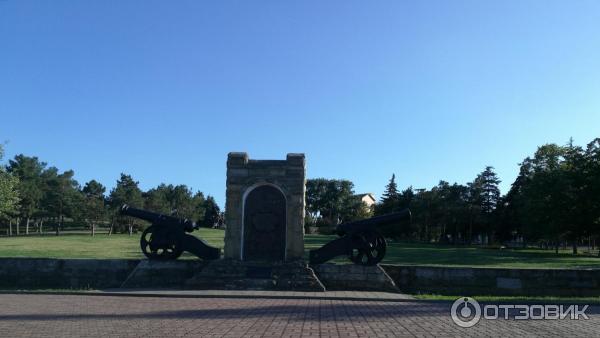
[0,147,223,235]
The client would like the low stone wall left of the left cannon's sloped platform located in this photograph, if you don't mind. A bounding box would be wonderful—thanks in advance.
[0,258,140,289]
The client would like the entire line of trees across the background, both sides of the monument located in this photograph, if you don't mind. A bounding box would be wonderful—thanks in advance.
[0,139,600,252]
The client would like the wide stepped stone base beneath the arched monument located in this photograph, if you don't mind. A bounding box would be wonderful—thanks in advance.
[184,259,325,291]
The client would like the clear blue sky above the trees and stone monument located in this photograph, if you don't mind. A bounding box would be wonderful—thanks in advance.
[0,0,600,205]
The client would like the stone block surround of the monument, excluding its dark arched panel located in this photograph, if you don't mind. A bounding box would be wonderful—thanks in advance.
[224,152,306,260]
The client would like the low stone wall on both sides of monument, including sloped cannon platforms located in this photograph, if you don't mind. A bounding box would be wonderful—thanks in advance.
[0,258,600,296]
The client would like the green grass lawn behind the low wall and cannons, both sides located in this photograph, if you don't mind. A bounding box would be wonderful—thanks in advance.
[0,229,600,268]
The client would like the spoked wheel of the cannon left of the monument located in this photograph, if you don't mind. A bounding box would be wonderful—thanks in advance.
[140,225,183,259]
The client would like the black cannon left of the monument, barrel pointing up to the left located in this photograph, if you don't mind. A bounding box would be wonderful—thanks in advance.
[120,204,221,259]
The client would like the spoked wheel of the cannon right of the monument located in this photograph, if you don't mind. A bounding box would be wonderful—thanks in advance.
[349,231,387,265]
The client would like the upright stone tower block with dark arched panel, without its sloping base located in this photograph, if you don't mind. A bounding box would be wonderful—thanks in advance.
[224,153,306,262]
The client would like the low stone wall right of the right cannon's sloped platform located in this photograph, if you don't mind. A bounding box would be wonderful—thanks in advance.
[382,265,600,296]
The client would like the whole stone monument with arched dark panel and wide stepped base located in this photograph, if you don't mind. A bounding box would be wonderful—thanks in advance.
[185,153,325,291]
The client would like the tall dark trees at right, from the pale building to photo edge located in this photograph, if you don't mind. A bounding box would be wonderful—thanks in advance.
[374,138,600,253]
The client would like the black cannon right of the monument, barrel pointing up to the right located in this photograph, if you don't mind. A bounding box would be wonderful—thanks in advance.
[310,209,411,265]
